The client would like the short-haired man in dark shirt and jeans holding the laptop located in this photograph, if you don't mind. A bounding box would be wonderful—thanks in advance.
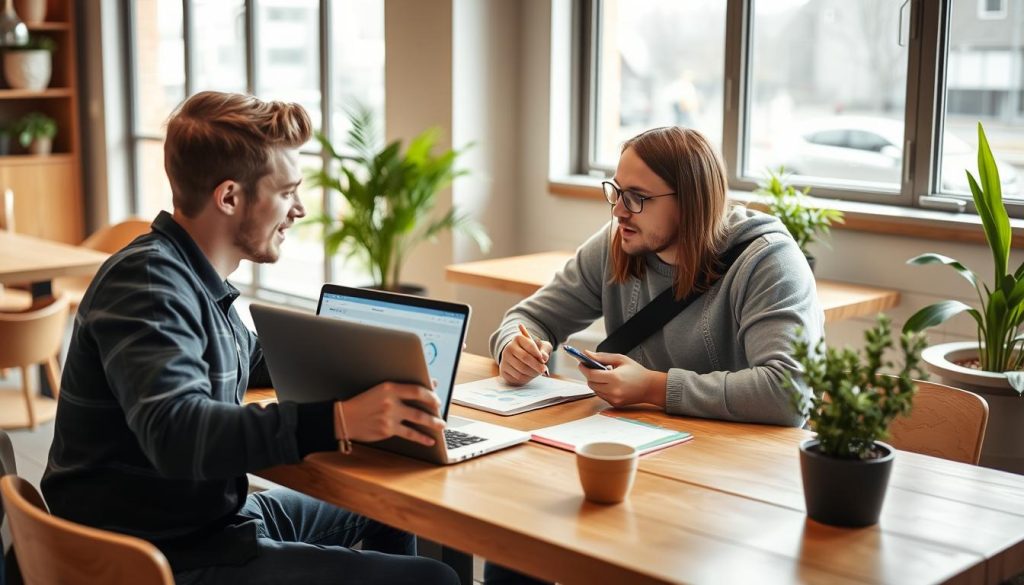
[42,92,457,585]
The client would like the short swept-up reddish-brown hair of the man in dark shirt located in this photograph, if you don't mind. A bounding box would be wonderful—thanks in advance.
[164,91,312,217]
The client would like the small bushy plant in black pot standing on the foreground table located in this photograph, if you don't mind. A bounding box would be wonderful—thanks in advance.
[787,315,926,527]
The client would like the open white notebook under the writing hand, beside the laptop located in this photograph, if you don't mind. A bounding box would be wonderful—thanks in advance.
[452,376,594,416]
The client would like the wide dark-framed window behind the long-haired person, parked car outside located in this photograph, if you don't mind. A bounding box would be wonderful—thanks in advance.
[577,0,1024,217]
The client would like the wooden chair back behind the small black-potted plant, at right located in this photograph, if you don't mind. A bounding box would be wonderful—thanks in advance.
[889,380,988,465]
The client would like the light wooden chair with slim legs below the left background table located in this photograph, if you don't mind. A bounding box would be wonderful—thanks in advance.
[0,296,68,428]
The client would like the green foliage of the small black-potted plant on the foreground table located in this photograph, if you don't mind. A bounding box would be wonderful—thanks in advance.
[786,315,927,459]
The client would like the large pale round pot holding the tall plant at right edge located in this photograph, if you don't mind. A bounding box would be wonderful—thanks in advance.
[921,341,1024,473]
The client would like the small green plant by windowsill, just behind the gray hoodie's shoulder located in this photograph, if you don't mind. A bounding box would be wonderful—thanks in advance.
[754,167,843,271]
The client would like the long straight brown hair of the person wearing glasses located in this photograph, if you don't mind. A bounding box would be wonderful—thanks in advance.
[611,126,726,299]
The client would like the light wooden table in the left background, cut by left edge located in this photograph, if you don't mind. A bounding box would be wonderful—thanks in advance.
[0,231,108,405]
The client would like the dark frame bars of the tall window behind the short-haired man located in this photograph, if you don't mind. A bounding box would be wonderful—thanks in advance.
[121,0,366,301]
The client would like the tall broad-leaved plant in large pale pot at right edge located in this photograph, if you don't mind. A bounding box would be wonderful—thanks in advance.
[903,123,1024,473]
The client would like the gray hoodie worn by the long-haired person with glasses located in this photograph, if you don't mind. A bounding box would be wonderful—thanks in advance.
[490,207,824,426]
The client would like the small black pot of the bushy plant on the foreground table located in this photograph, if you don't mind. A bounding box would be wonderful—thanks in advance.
[800,438,894,527]
